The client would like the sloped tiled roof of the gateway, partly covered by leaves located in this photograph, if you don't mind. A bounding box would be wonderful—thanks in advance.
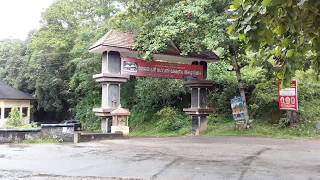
[89,30,219,61]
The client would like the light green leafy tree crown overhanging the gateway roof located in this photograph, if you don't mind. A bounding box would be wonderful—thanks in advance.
[128,0,228,58]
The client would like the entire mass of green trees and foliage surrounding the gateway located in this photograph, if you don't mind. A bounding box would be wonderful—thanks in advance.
[0,0,320,135]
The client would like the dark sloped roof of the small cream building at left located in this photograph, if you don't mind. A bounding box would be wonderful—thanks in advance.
[0,80,34,100]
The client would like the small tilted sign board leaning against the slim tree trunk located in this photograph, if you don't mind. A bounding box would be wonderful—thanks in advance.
[231,96,245,121]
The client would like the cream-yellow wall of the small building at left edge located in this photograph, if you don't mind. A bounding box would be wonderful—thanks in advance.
[0,100,31,128]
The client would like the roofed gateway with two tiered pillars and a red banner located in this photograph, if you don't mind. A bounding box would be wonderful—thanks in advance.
[90,31,218,135]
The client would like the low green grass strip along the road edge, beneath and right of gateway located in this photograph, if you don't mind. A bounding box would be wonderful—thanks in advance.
[130,116,320,139]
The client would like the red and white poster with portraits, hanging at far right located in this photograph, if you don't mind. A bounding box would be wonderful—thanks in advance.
[278,80,298,111]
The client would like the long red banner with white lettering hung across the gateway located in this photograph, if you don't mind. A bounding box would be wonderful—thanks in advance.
[121,58,203,80]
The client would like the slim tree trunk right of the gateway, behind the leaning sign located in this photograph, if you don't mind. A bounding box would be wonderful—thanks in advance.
[232,53,249,128]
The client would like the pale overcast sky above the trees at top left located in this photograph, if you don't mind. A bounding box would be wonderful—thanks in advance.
[0,0,54,40]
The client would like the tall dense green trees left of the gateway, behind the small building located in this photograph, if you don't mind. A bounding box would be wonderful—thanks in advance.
[0,0,119,129]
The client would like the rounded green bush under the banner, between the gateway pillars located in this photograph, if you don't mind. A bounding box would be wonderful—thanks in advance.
[153,107,191,131]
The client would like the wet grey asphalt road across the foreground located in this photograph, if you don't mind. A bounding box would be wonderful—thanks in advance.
[0,137,320,180]
